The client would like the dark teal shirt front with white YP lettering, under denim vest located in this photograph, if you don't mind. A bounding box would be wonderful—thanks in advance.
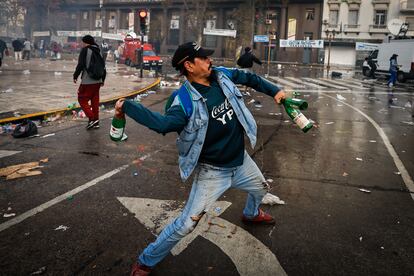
[191,79,244,168]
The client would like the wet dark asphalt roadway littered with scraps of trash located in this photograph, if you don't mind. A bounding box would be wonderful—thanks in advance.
[0,61,414,275]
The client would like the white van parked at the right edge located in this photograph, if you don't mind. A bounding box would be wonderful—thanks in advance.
[363,39,414,82]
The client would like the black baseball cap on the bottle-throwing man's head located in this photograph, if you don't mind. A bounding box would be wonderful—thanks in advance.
[171,42,214,70]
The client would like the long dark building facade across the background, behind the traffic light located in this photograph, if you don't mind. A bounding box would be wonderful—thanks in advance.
[22,0,323,63]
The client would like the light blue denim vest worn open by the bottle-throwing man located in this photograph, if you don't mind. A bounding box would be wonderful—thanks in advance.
[177,68,279,181]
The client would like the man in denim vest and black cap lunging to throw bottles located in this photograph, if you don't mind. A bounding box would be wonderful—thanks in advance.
[115,42,286,276]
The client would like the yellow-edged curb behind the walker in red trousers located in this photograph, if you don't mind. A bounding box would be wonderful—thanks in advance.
[0,78,161,124]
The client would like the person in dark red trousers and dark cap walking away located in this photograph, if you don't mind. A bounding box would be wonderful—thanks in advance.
[73,35,106,130]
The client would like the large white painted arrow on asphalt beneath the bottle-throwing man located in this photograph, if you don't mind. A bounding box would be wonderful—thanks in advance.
[118,197,287,276]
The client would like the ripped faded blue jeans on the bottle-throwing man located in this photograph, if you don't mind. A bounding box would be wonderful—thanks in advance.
[138,152,268,267]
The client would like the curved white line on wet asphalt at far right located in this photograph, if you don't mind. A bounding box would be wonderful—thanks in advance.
[322,93,414,200]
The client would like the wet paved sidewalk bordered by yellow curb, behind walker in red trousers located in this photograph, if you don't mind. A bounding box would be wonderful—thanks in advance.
[0,57,158,123]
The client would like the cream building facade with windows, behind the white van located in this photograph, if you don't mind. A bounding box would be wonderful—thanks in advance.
[321,0,414,66]
